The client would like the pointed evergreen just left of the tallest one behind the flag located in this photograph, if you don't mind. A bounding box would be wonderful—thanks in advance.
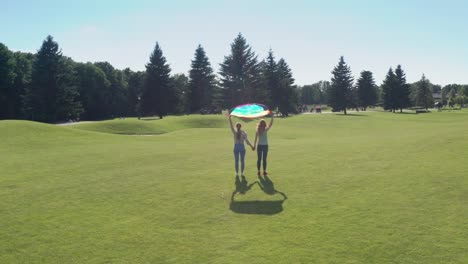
[188,45,216,113]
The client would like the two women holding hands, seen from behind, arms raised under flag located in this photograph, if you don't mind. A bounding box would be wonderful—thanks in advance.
[229,115,273,176]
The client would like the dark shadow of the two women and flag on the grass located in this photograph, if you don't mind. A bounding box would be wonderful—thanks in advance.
[229,176,288,215]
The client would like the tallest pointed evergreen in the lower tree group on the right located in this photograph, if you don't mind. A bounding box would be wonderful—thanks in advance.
[328,56,353,115]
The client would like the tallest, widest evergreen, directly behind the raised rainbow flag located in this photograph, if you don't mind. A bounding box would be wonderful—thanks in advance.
[220,33,265,107]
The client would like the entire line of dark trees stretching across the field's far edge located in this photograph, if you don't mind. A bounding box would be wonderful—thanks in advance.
[0,33,468,123]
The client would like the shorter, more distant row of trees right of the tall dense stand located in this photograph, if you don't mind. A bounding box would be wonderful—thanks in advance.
[298,57,468,114]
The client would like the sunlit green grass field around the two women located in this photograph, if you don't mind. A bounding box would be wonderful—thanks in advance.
[0,111,468,263]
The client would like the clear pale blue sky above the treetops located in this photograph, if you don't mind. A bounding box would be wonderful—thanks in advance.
[0,0,468,85]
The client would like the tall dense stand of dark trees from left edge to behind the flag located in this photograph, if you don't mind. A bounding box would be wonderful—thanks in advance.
[0,34,299,123]
